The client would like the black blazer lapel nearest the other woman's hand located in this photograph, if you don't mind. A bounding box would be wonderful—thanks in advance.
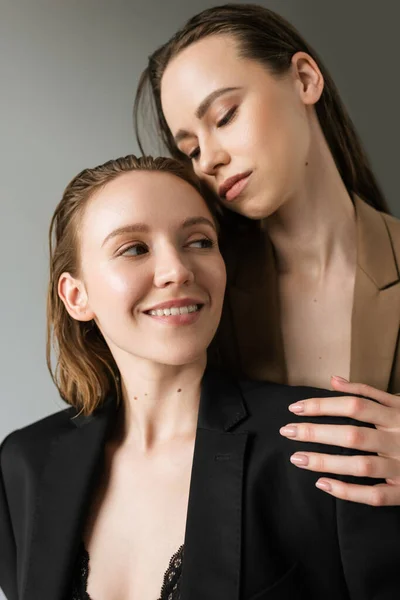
[181,372,247,600]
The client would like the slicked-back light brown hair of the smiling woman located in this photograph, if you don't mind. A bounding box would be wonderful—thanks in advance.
[46,155,217,415]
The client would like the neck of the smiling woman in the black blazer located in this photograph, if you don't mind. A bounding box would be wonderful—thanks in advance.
[112,356,206,452]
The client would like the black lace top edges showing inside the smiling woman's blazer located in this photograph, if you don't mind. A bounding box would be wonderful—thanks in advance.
[71,544,184,600]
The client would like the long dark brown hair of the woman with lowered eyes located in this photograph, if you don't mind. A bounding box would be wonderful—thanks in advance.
[134,4,390,213]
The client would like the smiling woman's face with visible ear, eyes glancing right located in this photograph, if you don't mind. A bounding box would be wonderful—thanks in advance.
[59,171,226,368]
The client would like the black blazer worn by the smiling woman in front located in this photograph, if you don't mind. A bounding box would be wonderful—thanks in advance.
[0,371,400,600]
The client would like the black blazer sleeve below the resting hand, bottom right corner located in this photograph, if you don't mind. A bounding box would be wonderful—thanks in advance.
[336,480,400,600]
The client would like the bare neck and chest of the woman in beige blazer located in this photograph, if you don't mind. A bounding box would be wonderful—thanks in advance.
[265,105,357,388]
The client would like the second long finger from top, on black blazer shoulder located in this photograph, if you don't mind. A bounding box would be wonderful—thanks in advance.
[279,423,400,456]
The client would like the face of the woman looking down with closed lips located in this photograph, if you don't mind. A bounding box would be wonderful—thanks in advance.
[161,35,323,219]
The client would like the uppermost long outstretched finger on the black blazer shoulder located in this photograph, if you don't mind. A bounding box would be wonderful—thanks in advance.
[289,396,400,428]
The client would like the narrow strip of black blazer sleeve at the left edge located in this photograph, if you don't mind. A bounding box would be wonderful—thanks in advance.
[0,436,18,600]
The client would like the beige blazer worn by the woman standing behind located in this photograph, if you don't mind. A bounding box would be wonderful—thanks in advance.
[210,197,400,393]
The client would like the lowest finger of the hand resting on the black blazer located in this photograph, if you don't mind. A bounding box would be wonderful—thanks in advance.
[315,477,400,506]
